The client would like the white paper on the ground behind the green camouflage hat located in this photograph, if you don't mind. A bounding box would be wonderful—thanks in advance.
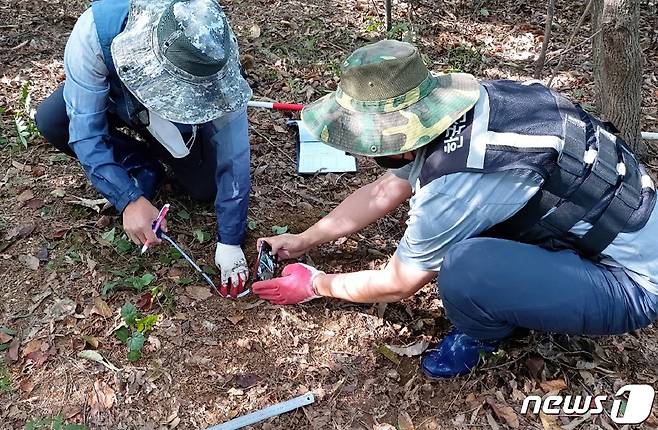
[295,121,356,174]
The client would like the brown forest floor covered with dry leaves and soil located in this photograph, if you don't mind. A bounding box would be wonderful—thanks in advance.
[0,0,658,430]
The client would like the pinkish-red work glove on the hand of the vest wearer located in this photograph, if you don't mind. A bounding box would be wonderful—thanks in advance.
[251,263,324,305]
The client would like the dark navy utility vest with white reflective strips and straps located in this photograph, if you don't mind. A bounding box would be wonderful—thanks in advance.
[418,81,656,258]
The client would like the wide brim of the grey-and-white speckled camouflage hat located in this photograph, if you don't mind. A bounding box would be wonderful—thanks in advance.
[111,0,252,124]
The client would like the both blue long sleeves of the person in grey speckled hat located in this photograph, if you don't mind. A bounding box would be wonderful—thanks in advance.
[64,9,250,245]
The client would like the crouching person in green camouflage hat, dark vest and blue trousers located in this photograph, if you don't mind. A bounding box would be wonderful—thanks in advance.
[253,41,658,378]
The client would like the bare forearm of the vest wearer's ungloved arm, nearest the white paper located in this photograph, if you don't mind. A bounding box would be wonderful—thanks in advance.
[301,173,411,246]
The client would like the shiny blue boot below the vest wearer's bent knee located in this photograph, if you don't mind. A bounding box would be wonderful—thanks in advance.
[420,329,498,379]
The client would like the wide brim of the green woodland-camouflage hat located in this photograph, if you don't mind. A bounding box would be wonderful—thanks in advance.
[302,73,480,157]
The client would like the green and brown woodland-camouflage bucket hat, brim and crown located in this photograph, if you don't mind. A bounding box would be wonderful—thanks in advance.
[302,40,480,157]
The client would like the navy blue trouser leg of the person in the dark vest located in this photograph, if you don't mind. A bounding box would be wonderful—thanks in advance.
[438,238,658,340]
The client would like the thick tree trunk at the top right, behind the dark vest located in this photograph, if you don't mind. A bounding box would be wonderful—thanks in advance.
[592,0,646,156]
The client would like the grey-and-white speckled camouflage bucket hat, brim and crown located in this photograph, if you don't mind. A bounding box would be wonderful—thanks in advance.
[112,0,252,124]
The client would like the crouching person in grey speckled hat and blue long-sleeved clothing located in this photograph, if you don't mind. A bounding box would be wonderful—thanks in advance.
[36,0,252,297]
